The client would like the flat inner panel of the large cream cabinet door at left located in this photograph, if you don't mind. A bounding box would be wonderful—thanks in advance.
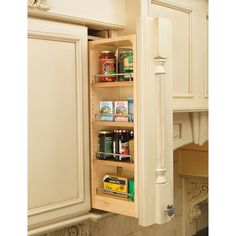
[29,38,79,208]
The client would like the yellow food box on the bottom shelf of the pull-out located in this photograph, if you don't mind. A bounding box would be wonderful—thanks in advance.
[103,175,133,198]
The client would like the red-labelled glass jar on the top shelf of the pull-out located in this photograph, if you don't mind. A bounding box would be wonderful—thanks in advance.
[99,51,116,82]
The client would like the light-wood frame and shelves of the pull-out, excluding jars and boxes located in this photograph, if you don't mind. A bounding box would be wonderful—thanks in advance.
[89,35,138,217]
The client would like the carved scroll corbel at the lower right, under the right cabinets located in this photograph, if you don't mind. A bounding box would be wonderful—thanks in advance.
[187,182,208,223]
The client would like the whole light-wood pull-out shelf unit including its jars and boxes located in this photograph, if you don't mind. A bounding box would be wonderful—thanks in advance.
[89,35,138,217]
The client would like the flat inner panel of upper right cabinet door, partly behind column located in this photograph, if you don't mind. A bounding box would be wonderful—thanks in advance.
[151,4,191,97]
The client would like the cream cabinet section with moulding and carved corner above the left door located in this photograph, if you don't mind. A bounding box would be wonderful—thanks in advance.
[28,0,127,30]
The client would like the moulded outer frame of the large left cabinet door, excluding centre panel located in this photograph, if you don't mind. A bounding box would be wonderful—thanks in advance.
[28,21,90,230]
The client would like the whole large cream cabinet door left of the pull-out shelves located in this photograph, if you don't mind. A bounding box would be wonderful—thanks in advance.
[28,19,90,229]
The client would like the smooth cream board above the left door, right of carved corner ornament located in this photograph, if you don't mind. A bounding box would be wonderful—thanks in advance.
[36,0,126,28]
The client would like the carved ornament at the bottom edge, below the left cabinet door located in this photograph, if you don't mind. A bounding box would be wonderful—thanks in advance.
[55,224,89,236]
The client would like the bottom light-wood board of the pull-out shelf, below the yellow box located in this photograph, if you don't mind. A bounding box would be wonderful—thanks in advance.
[92,192,138,218]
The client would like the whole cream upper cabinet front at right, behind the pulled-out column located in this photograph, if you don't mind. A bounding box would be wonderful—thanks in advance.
[150,0,208,111]
